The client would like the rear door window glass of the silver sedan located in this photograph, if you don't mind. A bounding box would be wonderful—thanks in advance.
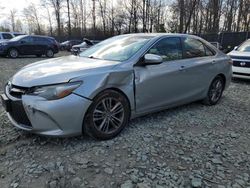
[183,38,206,58]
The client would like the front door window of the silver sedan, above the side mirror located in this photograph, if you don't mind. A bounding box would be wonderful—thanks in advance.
[148,37,182,61]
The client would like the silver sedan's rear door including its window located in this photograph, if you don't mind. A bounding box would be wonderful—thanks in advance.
[182,37,217,94]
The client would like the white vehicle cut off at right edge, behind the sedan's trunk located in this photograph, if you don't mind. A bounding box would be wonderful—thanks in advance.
[228,39,250,79]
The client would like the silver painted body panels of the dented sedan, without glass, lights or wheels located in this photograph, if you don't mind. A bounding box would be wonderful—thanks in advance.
[5,34,232,136]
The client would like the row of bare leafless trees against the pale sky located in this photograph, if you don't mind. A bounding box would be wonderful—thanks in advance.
[0,0,250,39]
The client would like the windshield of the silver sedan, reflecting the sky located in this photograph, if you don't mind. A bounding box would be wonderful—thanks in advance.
[80,35,153,61]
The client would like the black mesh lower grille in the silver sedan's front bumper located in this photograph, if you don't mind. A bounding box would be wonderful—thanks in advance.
[9,101,31,127]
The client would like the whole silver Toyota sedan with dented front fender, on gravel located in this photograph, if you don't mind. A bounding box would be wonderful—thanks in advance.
[1,34,232,139]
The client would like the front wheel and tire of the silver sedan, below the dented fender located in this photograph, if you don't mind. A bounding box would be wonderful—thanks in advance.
[83,89,130,140]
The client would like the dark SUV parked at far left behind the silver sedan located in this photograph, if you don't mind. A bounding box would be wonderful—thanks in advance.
[0,35,59,58]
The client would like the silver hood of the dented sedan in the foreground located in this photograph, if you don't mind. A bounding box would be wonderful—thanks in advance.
[10,55,119,87]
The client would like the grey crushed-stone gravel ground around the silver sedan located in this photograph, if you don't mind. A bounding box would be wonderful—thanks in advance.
[0,54,250,188]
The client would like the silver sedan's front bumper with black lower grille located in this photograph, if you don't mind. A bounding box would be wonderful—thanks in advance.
[1,85,91,136]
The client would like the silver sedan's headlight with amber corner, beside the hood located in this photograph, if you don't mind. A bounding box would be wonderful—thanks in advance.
[30,82,82,100]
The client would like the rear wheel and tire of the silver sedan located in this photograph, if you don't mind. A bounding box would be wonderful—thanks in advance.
[203,75,225,106]
